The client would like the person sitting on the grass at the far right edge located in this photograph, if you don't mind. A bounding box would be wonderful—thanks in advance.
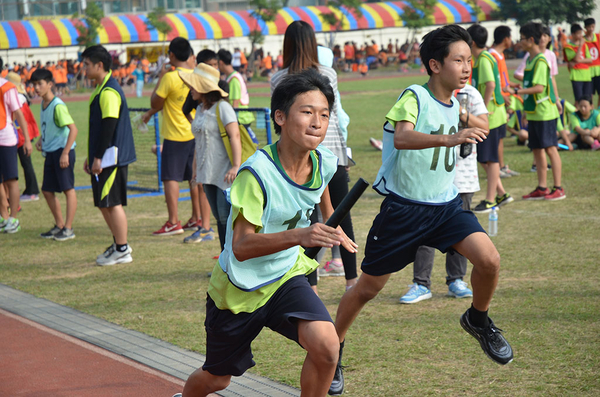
[559,95,600,150]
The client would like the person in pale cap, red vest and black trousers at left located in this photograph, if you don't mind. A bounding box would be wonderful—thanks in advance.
[6,72,40,202]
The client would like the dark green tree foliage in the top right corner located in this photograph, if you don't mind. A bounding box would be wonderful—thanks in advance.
[492,0,596,26]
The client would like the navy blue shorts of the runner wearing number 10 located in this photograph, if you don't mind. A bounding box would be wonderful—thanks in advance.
[361,194,485,276]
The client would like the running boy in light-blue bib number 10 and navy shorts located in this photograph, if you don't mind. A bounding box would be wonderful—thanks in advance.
[329,25,512,395]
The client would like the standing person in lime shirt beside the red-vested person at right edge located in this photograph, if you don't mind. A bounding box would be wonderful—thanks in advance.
[564,23,593,105]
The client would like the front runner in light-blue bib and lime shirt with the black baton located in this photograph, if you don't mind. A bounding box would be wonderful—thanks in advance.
[176,68,357,397]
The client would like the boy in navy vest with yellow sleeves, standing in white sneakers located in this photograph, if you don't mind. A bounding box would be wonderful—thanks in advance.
[81,45,136,266]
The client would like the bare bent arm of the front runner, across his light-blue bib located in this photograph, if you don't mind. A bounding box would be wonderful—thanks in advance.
[231,212,343,261]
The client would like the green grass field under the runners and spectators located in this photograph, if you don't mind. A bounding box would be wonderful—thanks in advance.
[0,68,600,396]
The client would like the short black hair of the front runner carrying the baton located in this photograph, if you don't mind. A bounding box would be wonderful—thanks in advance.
[271,68,335,135]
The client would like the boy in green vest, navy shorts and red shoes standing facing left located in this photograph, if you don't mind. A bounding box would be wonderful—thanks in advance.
[508,22,564,201]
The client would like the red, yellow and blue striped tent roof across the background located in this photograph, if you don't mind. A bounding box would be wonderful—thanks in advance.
[0,0,498,49]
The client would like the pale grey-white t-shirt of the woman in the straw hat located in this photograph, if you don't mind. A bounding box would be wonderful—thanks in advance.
[192,101,237,190]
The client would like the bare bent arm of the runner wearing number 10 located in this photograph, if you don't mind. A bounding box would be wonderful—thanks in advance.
[394,121,489,150]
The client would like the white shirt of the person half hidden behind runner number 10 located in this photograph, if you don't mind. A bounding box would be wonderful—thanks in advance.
[454,84,488,193]
